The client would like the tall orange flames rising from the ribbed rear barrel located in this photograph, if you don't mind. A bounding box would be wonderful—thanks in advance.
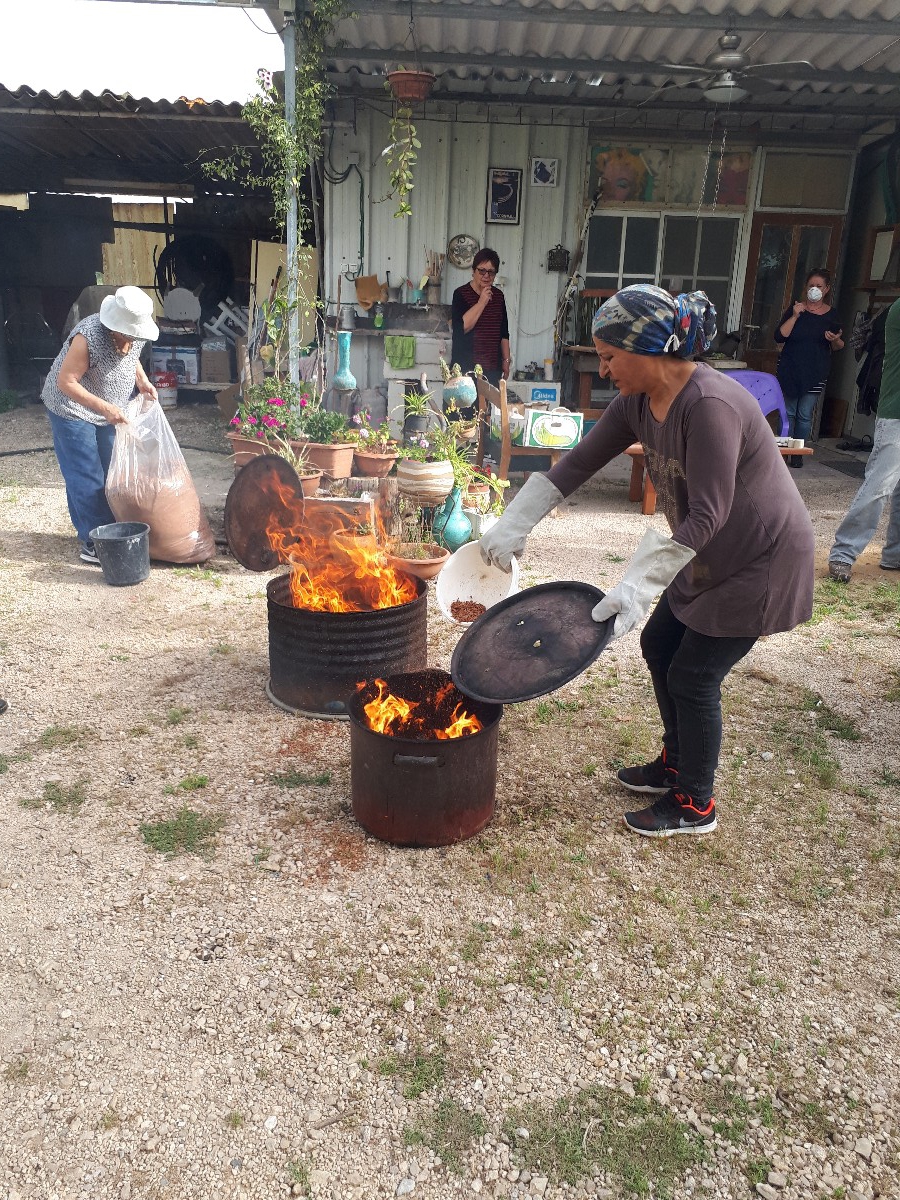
[259,480,418,612]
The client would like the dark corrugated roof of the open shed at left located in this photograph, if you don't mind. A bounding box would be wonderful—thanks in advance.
[0,85,253,192]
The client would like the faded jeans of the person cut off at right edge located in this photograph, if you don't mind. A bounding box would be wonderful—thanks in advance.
[828,418,900,568]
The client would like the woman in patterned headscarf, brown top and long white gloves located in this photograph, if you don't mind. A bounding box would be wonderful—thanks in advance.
[481,283,814,838]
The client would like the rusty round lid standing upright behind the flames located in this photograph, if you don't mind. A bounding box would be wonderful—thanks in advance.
[224,454,304,571]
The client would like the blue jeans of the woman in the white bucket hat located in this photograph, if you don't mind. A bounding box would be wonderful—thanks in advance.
[48,409,115,541]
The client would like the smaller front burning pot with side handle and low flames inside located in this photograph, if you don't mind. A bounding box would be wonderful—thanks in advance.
[348,671,503,846]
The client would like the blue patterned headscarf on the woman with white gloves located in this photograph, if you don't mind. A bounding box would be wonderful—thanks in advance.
[592,283,715,359]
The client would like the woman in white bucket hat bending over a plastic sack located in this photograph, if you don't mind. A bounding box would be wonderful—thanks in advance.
[41,287,160,563]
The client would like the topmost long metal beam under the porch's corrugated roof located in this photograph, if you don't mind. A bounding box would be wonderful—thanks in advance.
[336,0,900,37]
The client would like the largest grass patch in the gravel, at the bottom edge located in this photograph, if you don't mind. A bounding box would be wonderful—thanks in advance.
[503,1085,702,1196]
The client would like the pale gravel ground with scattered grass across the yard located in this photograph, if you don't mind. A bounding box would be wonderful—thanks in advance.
[0,406,900,1200]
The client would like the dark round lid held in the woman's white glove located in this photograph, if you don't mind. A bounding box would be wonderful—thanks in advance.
[450,581,616,704]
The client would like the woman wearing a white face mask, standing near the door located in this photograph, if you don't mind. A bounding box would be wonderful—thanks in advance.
[775,268,844,467]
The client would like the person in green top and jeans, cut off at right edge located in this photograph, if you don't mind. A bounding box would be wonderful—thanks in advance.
[828,300,900,583]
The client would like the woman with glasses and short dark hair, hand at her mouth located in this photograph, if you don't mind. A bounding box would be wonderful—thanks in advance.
[450,246,512,384]
